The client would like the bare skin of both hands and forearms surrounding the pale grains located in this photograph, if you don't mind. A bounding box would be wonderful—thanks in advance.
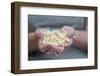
[28,25,88,55]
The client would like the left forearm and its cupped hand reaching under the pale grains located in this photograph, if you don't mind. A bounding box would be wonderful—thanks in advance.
[28,28,67,55]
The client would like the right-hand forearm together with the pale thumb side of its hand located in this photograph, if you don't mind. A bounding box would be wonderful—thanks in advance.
[62,26,88,50]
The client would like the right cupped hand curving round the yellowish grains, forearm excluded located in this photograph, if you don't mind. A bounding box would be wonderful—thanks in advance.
[61,25,75,47]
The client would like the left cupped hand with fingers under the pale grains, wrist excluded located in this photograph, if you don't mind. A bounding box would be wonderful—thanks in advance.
[35,28,64,55]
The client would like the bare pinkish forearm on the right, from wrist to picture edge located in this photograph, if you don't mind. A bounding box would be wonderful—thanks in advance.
[73,30,88,50]
